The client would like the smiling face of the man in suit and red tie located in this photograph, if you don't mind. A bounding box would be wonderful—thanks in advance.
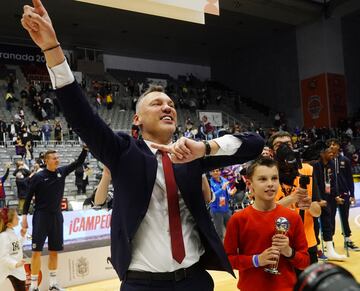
[134,92,177,139]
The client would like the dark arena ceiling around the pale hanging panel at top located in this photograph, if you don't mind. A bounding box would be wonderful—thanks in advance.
[0,0,360,64]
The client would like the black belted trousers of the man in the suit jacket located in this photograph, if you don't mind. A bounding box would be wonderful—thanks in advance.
[120,270,214,291]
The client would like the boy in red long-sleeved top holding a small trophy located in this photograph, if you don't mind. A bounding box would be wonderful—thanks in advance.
[224,157,309,291]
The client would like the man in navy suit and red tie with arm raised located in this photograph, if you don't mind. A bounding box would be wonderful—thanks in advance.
[21,0,264,291]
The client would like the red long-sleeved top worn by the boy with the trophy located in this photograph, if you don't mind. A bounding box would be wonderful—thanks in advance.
[224,205,309,291]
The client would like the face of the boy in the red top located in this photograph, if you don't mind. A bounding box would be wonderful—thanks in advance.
[248,166,279,201]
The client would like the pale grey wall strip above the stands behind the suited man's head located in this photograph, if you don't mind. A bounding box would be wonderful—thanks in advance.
[104,54,211,80]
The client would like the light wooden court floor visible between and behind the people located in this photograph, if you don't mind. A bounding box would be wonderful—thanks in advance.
[67,225,360,291]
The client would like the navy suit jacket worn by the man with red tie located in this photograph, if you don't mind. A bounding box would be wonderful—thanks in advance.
[56,82,264,279]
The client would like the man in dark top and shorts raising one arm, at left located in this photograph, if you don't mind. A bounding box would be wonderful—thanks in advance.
[22,147,88,291]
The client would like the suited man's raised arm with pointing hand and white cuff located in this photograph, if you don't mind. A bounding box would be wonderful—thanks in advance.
[21,0,130,166]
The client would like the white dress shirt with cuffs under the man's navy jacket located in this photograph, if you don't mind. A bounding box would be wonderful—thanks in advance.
[48,61,241,272]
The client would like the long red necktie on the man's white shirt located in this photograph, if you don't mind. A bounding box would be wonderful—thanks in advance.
[160,151,185,264]
